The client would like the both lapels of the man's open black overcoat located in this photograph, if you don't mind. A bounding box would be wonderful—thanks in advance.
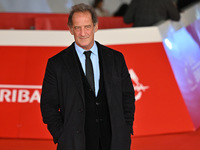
[63,42,114,102]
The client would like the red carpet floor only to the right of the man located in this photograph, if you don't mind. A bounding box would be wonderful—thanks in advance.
[131,128,200,150]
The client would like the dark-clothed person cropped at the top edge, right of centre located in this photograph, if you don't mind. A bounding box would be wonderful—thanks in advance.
[124,0,180,27]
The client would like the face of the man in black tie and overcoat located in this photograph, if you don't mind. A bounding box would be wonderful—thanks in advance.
[70,12,98,50]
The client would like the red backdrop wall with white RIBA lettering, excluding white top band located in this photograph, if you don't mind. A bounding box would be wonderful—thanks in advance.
[0,43,193,138]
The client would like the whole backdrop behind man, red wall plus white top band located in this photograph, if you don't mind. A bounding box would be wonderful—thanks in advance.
[0,24,200,139]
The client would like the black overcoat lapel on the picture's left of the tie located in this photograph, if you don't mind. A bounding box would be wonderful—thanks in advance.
[63,43,84,100]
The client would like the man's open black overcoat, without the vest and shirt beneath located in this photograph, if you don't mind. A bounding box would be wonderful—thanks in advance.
[41,42,135,150]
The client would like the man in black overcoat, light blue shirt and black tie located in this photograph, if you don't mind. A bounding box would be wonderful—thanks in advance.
[41,4,135,150]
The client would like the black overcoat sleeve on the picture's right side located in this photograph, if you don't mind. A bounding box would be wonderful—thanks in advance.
[121,53,135,135]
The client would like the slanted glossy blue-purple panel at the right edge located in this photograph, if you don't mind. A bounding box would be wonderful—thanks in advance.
[163,25,200,128]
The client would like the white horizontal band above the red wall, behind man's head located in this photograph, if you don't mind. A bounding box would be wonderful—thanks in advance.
[0,27,162,46]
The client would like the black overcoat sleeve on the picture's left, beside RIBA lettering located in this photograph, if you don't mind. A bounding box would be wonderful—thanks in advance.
[40,60,63,143]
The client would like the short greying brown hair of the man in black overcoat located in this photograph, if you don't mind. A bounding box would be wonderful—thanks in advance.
[67,3,98,28]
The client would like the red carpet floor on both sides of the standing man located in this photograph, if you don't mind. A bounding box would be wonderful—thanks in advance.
[0,129,200,150]
